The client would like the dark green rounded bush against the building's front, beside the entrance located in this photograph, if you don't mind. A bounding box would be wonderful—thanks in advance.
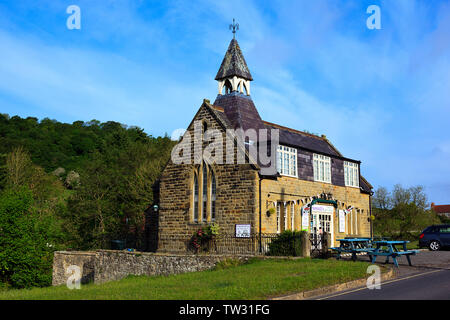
[267,230,305,256]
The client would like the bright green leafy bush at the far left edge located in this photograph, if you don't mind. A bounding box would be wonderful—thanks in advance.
[0,187,56,288]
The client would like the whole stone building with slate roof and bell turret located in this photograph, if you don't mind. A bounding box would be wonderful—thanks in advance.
[155,39,372,251]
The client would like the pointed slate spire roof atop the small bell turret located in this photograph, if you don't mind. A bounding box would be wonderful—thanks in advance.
[216,39,253,81]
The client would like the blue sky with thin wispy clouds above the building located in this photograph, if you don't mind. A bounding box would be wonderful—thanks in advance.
[0,0,450,204]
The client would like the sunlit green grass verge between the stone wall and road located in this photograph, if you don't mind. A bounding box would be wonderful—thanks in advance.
[0,258,369,300]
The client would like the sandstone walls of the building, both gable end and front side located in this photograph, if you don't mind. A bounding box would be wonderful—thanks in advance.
[158,103,370,252]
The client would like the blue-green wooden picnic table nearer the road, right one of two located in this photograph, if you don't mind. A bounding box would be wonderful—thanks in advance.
[368,240,417,268]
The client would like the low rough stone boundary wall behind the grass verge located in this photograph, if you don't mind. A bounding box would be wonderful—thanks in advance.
[52,250,253,286]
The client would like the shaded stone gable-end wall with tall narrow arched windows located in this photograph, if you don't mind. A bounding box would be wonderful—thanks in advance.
[158,104,258,252]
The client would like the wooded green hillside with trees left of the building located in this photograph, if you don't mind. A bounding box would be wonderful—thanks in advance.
[0,115,174,287]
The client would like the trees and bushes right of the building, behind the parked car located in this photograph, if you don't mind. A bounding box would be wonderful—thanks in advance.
[372,185,439,240]
